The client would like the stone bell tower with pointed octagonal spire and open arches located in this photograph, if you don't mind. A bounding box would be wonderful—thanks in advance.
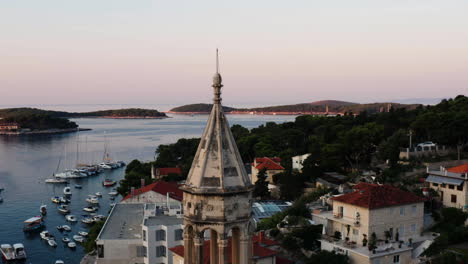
[182,50,255,264]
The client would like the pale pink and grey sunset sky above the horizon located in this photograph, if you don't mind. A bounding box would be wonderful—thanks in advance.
[0,0,468,105]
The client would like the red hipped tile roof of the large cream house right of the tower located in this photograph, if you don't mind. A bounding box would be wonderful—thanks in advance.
[332,182,425,209]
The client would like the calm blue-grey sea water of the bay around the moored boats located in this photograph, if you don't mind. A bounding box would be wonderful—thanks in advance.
[0,115,295,264]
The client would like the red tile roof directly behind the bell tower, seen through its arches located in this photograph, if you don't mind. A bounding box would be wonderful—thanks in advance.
[169,235,286,264]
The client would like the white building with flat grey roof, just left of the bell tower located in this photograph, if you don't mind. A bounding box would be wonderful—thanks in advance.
[96,203,183,264]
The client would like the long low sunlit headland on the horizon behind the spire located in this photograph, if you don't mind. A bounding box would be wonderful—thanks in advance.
[166,100,419,115]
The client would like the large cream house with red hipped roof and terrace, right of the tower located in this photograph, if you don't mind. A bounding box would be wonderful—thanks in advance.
[312,183,433,264]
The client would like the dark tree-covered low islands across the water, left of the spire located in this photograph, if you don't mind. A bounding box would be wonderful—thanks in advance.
[0,108,168,135]
